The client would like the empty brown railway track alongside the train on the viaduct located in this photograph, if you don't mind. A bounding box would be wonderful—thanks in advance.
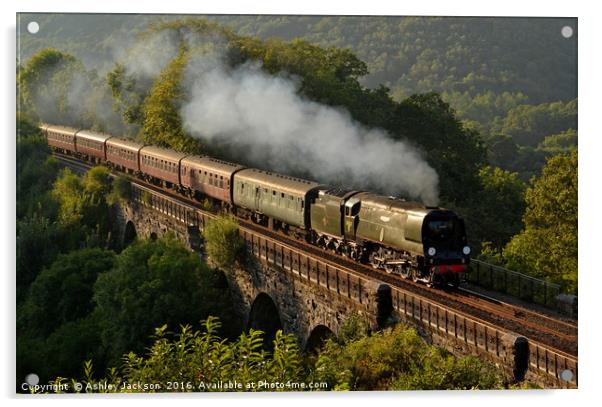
[55,153,578,357]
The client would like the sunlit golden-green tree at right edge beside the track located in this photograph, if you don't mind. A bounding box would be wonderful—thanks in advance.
[503,151,578,293]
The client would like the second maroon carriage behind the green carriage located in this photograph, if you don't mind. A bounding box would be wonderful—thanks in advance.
[140,146,187,185]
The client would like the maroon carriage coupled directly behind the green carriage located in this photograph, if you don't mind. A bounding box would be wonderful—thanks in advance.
[180,155,245,204]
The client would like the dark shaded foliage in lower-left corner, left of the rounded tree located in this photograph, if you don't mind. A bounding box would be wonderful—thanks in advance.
[17,249,115,382]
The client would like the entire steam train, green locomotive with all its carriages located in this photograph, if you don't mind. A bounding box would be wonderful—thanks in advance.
[40,124,470,286]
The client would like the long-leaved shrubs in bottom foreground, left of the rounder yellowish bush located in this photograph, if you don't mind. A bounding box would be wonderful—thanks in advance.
[51,317,303,392]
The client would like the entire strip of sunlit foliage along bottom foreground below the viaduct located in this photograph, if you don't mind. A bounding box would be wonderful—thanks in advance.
[47,317,503,392]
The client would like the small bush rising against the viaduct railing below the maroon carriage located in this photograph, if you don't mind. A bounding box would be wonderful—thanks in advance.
[203,214,245,269]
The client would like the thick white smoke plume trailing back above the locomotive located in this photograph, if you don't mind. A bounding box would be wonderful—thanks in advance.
[181,58,438,205]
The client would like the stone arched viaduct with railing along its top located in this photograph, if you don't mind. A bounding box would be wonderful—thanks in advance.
[115,184,577,387]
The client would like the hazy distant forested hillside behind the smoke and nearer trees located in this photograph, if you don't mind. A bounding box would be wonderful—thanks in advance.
[21,14,577,175]
